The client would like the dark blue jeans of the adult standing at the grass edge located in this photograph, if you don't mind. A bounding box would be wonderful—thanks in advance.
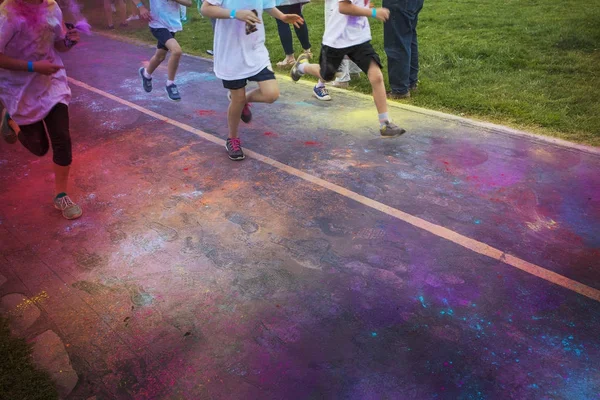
[383,0,424,94]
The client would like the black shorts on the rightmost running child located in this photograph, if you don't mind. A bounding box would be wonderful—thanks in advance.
[319,42,382,81]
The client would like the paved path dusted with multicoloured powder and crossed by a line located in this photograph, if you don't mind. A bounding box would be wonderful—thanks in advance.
[0,36,600,400]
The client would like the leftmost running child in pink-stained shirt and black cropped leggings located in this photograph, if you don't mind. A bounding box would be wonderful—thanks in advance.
[0,0,82,219]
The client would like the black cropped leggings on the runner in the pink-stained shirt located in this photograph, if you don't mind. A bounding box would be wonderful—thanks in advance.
[19,103,72,167]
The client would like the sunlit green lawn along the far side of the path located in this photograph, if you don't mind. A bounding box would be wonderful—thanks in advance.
[81,0,600,146]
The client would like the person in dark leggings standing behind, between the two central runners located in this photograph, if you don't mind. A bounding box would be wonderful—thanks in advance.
[277,0,312,67]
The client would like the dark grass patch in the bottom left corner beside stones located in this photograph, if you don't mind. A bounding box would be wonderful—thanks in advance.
[0,316,58,400]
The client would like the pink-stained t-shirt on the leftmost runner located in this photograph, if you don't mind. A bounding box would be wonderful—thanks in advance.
[0,0,71,125]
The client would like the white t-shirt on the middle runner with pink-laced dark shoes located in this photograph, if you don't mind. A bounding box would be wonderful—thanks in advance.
[207,0,275,81]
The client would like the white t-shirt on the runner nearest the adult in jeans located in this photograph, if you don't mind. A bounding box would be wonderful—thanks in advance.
[323,0,371,49]
